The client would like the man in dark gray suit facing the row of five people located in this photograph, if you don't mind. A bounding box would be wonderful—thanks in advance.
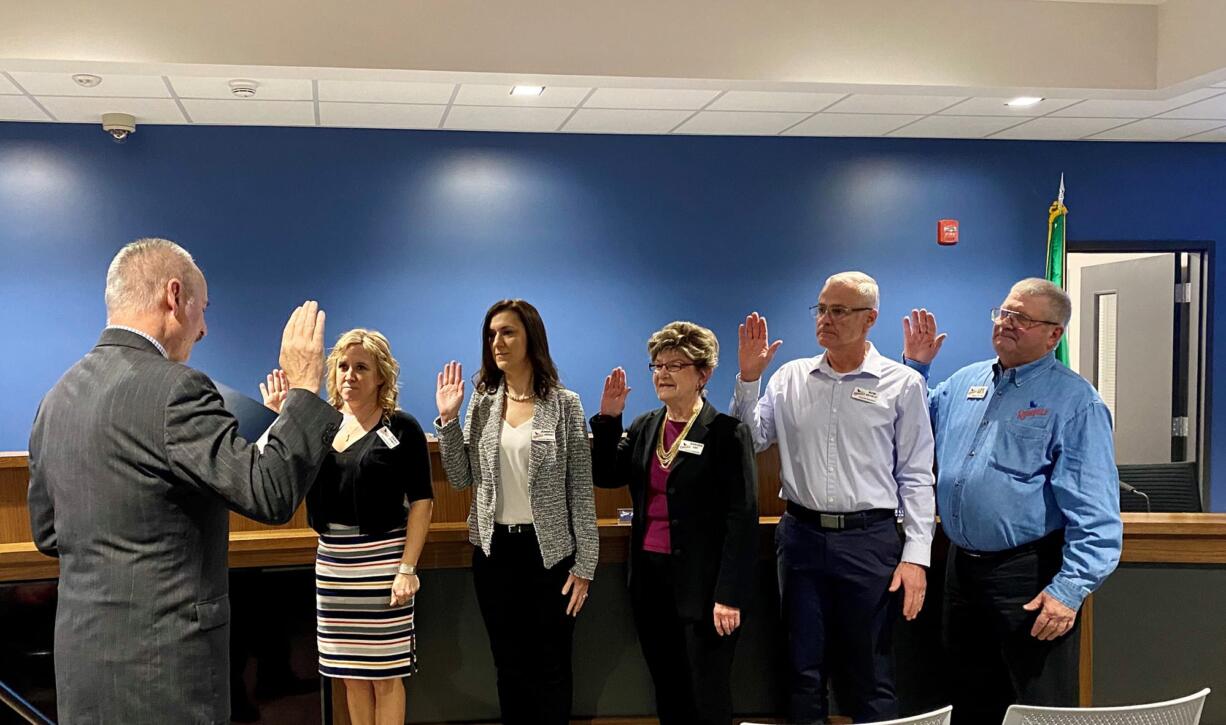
[29,239,341,725]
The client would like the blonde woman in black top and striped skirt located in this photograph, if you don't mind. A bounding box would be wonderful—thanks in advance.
[260,329,433,725]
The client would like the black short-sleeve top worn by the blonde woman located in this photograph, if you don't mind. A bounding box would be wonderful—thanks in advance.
[307,411,434,534]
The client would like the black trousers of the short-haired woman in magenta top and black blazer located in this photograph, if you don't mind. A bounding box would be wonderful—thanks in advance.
[630,551,741,725]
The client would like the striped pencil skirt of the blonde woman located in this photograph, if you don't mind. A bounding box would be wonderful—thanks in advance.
[315,525,417,680]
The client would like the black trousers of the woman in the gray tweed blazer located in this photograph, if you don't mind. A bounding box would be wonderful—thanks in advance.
[472,531,575,725]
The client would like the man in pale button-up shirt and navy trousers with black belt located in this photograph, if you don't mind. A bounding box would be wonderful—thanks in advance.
[732,272,935,723]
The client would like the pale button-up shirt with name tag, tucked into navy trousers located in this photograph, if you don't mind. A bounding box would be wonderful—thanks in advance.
[731,345,935,567]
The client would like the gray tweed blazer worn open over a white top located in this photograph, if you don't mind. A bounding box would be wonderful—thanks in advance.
[434,382,600,579]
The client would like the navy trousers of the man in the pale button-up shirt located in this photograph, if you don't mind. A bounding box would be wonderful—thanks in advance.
[775,514,902,723]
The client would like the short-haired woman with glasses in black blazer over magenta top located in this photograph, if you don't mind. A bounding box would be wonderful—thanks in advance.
[591,321,758,725]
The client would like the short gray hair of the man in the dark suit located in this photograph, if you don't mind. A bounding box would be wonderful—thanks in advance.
[107,237,201,315]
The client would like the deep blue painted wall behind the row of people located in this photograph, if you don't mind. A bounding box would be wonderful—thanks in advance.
[0,124,1226,510]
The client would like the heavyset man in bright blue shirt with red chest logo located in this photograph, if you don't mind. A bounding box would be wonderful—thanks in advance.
[902,278,1123,725]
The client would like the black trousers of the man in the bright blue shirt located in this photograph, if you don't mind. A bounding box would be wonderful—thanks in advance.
[944,532,1081,725]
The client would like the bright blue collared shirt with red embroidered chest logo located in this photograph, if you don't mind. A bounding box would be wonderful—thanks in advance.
[907,355,1123,608]
